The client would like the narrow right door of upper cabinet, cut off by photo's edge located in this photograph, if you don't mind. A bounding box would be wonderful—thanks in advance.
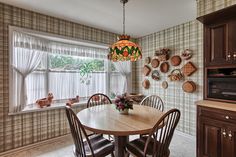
[228,19,236,64]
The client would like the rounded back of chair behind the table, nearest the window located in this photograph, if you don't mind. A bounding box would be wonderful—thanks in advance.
[87,93,112,108]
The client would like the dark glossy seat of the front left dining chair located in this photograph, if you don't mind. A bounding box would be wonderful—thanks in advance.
[75,134,114,157]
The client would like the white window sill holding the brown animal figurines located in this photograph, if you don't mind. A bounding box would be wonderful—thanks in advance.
[8,100,87,115]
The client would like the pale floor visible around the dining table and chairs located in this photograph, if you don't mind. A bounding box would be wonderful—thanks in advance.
[4,131,196,157]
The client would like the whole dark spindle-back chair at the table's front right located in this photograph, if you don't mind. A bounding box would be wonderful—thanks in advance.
[126,109,180,157]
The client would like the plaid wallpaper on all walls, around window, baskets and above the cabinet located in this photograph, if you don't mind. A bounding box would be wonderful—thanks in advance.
[0,0,236,152]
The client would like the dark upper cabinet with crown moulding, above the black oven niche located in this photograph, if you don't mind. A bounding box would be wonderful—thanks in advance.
[198,5,236,67]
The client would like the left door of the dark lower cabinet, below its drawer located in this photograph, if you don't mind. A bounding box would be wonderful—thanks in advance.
[198,117,226,157]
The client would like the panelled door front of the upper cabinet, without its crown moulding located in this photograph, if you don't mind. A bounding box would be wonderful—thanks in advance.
[204,19,236,67]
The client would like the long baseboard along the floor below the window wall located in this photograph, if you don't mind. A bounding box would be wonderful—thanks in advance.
[0,134,71,157]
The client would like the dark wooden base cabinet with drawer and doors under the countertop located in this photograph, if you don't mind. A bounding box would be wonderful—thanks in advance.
[197,106,236,157]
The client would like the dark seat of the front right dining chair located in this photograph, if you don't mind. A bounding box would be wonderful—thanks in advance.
[126,136,170,157]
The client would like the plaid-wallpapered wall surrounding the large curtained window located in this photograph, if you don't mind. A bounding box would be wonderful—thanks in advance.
[0,3,117,152]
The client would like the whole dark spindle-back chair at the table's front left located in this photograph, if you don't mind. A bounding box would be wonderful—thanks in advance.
[66,106,114,157]
